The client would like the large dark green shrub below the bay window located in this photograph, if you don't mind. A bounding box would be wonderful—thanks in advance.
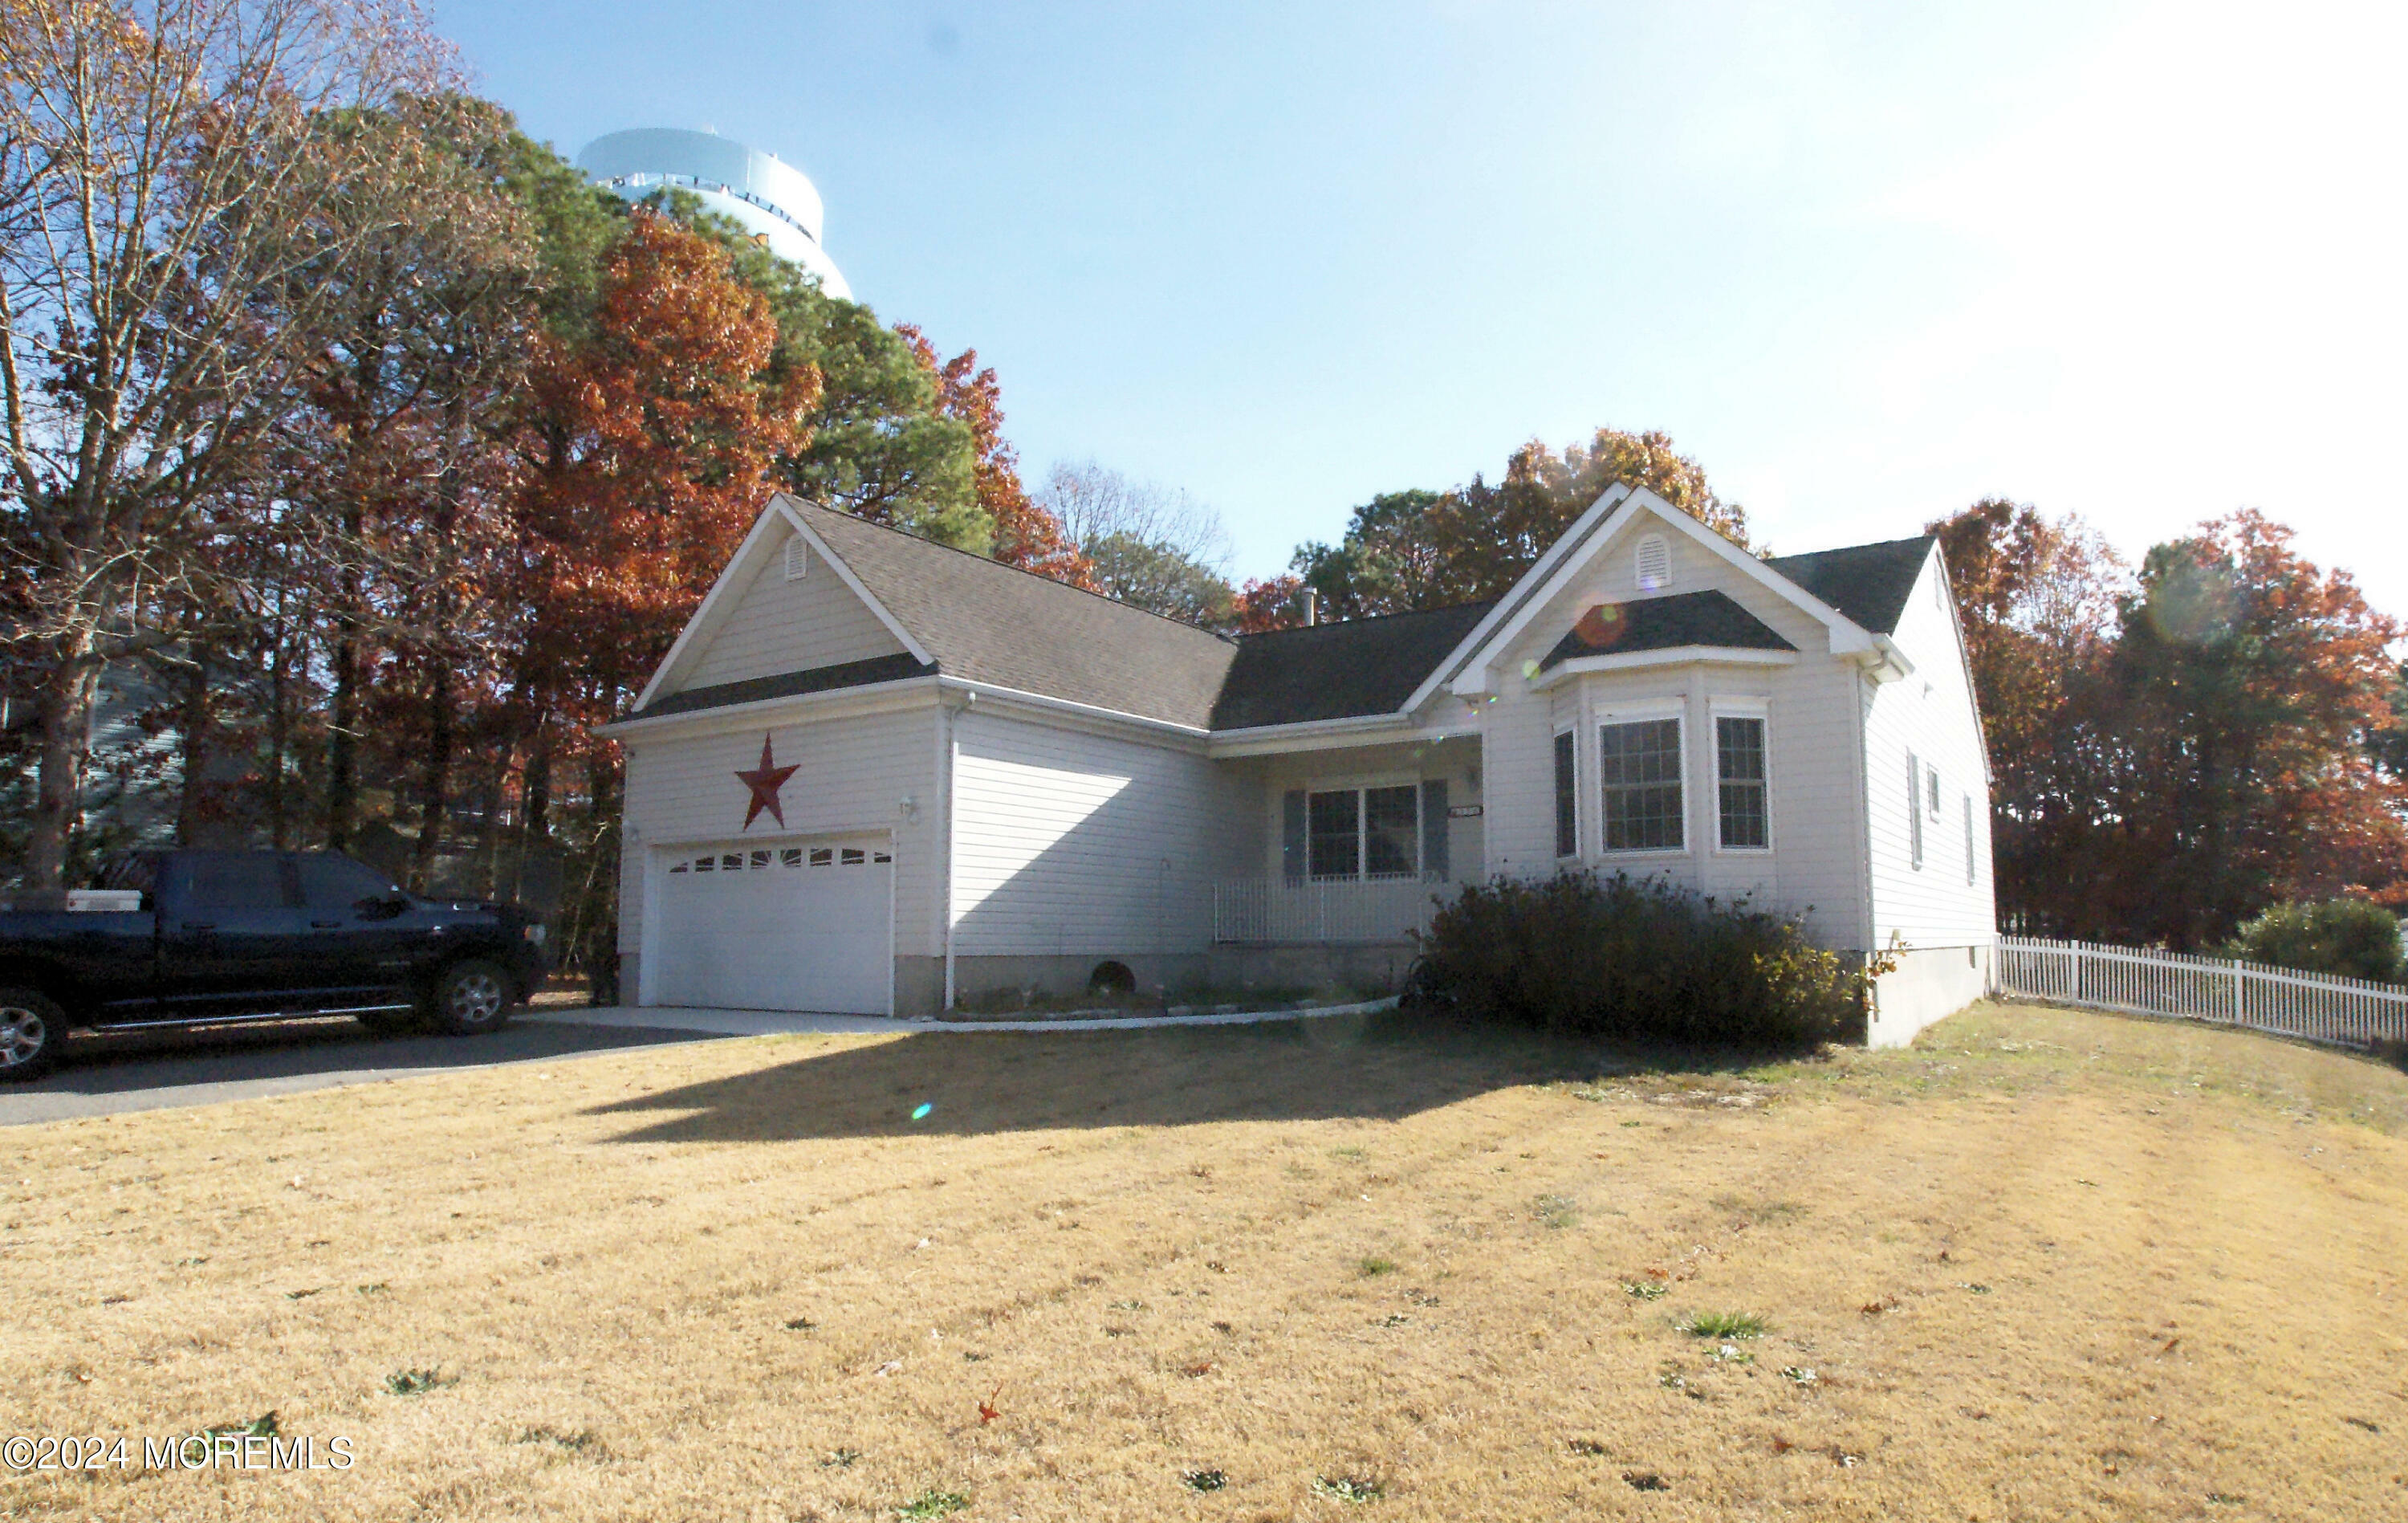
[1406,870,1864,1046]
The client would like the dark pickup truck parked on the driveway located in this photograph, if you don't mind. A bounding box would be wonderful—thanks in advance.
[0,851,544,1082]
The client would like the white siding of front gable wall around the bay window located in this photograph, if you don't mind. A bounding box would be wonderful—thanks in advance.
[1481,518,1869,947]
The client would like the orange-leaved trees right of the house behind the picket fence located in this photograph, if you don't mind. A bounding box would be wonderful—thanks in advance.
[1929,499,2408,947]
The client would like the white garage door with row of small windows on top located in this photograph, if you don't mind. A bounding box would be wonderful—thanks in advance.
[645,839,896,1015]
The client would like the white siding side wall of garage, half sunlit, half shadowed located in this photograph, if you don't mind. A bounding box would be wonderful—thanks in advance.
[951,711,1235,957]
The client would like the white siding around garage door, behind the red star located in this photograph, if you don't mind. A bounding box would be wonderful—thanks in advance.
[619,701,942,959]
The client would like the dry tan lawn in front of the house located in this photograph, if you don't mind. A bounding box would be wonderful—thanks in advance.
[0,1008,2408,1521]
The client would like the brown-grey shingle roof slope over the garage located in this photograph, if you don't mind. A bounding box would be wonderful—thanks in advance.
[783,496,1238,730]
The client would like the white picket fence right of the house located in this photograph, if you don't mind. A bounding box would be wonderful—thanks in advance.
[1994,935,2408,1046]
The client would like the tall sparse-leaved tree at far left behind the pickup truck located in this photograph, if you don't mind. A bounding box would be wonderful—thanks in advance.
[0,0,441,887]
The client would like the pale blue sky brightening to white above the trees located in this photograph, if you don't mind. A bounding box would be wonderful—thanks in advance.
[433,0,2408,614]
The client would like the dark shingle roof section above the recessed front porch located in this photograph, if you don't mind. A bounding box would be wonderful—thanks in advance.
[1211,602,1495,730]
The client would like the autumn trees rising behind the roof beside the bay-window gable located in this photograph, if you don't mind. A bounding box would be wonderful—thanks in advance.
[1291,429,1748,619]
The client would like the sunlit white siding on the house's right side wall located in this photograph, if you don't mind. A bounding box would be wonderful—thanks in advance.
[1866,556,1999,947]
